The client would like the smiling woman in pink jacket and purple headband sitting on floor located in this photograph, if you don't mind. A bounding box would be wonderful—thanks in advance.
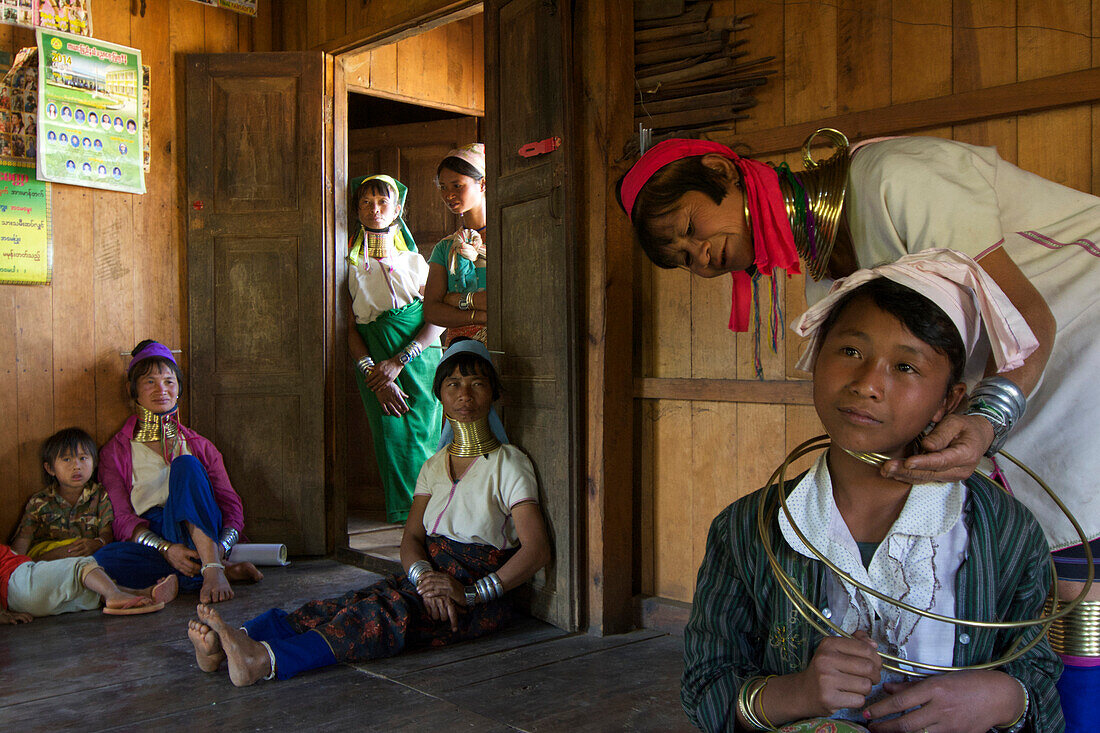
[95,340,263,603]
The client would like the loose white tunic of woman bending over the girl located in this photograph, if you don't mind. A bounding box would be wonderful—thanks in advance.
[806,138,1100,549]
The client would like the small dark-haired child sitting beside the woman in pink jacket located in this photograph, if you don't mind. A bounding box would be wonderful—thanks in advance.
[11,428,114,560]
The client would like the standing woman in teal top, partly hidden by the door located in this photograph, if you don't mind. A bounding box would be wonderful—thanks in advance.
[424,143,488,346]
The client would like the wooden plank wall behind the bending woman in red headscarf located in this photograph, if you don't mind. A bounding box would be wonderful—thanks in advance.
[635,0,1100,601]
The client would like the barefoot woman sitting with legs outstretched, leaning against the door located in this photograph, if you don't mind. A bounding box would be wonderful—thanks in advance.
[187,339,550,687]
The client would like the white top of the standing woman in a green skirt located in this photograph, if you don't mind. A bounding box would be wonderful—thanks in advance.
[348,250,428,324]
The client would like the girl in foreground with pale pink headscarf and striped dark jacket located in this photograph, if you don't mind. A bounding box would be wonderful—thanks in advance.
[681,250,1064,733]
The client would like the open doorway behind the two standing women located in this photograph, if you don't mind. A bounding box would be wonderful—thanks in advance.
[334,13,485,572]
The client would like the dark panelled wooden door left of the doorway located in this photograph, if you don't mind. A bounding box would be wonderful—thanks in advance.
[186,53,333,555]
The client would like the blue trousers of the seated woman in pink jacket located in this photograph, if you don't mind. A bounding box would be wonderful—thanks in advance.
[94,456,221,591]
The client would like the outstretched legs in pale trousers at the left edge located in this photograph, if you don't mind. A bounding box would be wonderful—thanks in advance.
[0,545,178,624]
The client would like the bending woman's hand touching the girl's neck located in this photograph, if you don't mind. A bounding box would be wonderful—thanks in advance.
[881,414,993,483]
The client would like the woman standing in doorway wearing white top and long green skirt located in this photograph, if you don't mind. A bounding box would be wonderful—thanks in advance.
[348,176,443,523]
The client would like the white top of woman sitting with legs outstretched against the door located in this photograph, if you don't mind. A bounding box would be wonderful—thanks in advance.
[414,445,539,549]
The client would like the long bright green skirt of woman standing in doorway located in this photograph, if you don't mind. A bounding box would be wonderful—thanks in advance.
[355,300,443,522]
